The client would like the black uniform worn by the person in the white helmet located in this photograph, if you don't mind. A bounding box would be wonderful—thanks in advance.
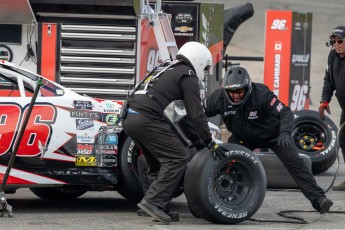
[123,62,212,209]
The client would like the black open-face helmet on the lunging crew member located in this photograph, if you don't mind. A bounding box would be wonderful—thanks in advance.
[223,66,252,105]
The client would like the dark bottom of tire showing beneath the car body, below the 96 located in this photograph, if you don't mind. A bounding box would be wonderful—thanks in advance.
[30,186,87,200]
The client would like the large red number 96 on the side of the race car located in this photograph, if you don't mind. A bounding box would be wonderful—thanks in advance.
[0,103,56,157]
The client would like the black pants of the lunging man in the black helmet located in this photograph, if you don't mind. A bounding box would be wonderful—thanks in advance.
[228,135,325,208]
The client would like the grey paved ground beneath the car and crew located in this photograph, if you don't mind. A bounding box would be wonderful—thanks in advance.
[0,158,345,230]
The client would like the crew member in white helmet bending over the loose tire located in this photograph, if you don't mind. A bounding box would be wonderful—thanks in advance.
[122,42,227,224]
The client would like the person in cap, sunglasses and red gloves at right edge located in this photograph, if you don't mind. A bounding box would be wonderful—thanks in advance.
[319,26,345,191]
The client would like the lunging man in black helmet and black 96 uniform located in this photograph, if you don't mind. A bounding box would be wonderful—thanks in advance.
[203,67,333,214]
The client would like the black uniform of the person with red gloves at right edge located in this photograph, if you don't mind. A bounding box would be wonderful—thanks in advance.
[321,49,345,161]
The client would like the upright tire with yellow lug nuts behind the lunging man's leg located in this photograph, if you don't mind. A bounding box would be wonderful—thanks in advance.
[292,110,338,175]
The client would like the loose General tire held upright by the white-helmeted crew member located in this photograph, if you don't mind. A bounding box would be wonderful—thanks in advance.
[184,144,266,224]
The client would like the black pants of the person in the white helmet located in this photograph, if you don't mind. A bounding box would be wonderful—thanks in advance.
[123,114,191,209]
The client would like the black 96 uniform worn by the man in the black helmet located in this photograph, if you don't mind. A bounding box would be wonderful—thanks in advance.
[203,83,325,209]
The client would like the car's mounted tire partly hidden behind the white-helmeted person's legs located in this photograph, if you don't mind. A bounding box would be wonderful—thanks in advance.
[117,137,144,202]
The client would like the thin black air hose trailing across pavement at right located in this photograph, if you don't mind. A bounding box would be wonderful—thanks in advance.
[249,123,345,224]
